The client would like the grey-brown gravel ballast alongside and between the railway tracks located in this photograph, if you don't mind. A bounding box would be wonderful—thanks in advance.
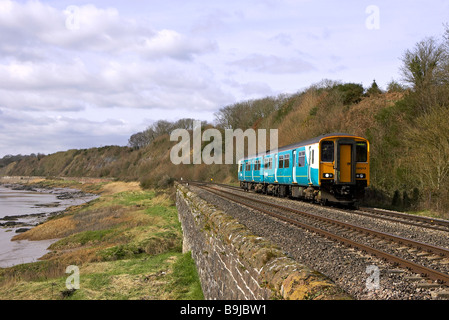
[191,186,449,300]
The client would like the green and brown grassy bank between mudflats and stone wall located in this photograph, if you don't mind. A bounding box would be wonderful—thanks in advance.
[0,181,204,300]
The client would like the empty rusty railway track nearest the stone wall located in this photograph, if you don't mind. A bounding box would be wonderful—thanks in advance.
[187,184,449,286]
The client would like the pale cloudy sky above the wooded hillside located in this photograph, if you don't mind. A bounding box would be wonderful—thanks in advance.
[0,0,449,157]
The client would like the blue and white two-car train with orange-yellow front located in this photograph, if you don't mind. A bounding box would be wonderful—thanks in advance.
[238,133,370,204]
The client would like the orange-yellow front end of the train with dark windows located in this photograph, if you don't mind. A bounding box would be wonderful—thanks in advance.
[319,136,369,204]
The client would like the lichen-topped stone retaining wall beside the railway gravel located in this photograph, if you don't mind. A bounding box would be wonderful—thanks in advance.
[176,184,350,300]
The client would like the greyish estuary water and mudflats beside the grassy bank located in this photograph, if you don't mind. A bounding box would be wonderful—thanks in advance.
[0,185,96,268]
